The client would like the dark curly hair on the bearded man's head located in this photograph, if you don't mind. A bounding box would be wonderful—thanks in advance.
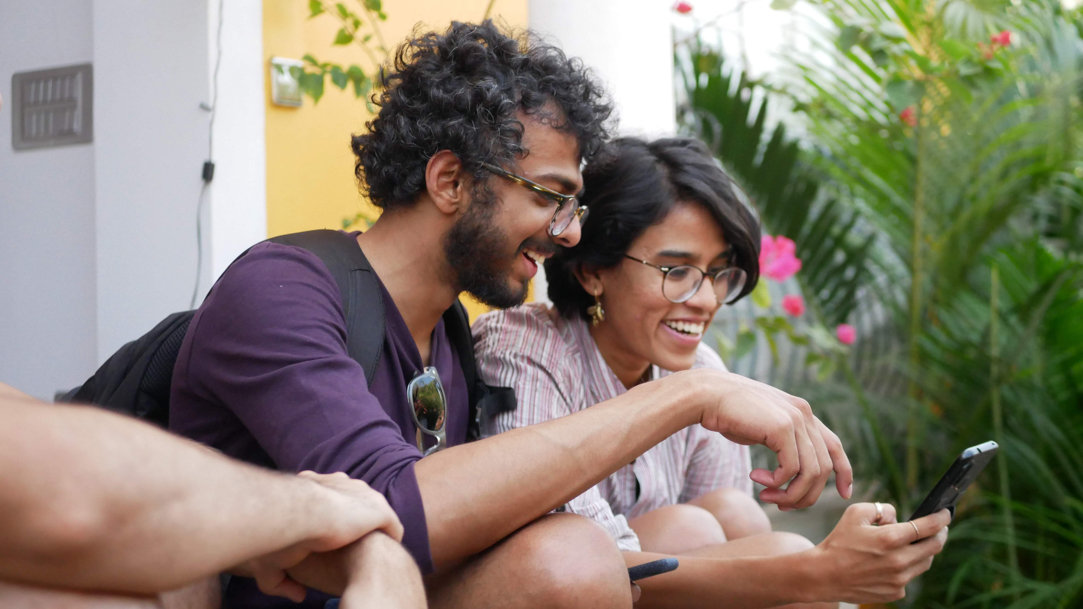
[351,21,612,209]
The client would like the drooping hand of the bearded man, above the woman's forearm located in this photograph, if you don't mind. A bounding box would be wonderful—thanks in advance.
[688,370,853,509]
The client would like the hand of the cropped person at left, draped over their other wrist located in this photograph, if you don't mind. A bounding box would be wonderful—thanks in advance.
[236,471,403,602]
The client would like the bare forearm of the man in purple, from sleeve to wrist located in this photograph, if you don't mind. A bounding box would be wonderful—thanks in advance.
[416,377,699,568]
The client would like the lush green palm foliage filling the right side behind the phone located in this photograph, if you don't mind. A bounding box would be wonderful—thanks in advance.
[687,0,1083,608]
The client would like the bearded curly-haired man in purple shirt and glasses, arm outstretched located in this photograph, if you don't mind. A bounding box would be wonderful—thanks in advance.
[170,23,922,608]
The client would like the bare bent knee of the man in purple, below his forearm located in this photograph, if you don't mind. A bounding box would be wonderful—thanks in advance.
[426,514,631,609]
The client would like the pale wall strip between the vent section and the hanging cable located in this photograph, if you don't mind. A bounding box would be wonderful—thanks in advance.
[93,0,209,360]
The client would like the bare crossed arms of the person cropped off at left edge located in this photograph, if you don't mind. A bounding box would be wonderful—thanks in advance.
[0,384,425,608]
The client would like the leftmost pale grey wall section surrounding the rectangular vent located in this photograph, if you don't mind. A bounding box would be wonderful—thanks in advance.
[0,0,97,398]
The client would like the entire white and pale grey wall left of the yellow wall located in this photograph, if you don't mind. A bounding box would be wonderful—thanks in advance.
[0,0,266,398]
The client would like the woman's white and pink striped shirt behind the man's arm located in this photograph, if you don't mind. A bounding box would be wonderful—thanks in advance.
[473,303,752,550]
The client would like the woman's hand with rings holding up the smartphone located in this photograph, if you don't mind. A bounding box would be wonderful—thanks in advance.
[809,503,951,602]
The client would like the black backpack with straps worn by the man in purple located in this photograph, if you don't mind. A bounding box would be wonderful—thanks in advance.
[56,230,514,440]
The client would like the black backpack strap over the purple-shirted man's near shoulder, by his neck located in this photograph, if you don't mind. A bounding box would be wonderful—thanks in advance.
[268,229,384,383]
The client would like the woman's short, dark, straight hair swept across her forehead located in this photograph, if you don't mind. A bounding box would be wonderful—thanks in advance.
[545,138,760,319]
